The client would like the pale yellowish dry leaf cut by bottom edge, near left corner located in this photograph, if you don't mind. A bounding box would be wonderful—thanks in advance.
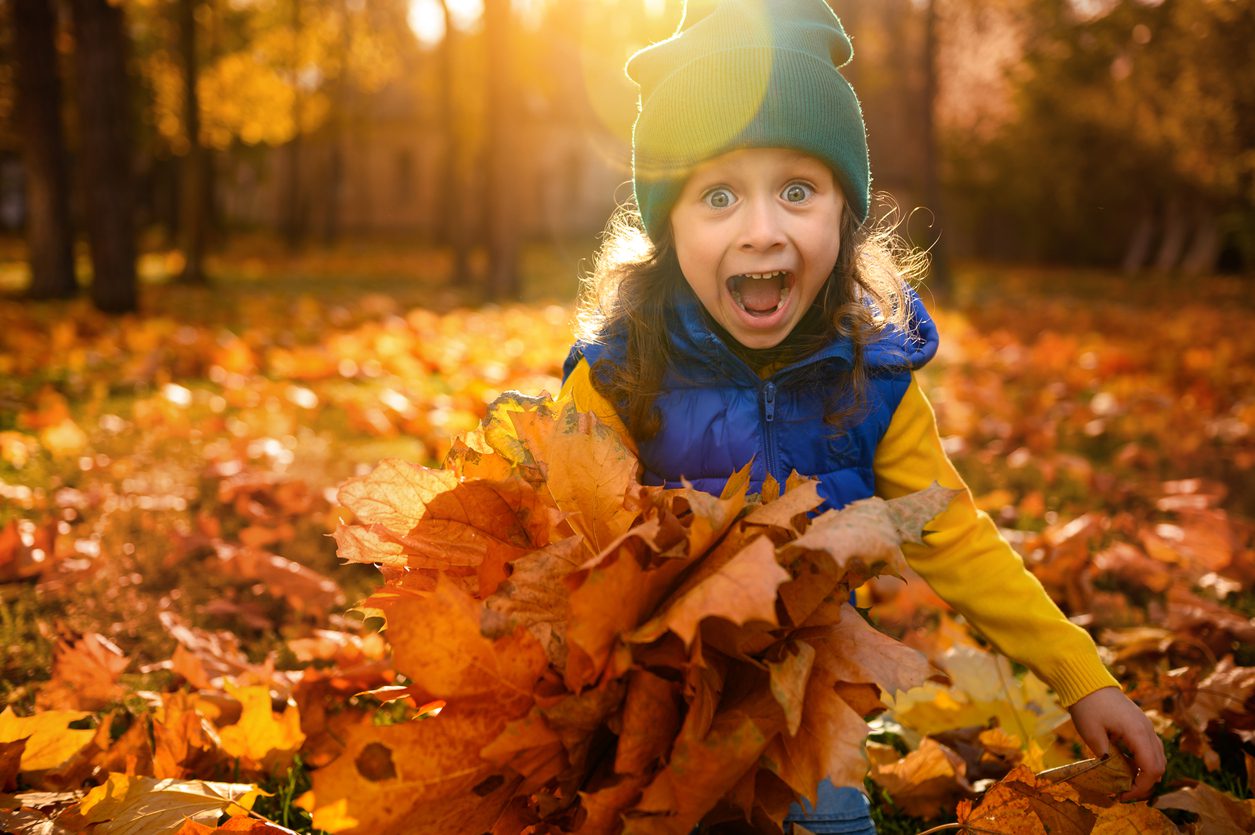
[78,773,261,835]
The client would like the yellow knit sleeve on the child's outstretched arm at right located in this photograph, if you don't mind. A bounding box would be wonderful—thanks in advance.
[875,375,1117,706]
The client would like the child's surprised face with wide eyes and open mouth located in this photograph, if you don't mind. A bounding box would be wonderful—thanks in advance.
[671,148,845,348]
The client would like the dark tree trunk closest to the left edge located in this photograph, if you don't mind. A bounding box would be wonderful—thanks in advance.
[13,0,78,299]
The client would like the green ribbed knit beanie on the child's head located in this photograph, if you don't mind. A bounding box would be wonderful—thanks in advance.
[626,0,871,241]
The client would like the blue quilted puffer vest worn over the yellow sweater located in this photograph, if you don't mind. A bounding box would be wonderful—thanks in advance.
[563,288,937,507]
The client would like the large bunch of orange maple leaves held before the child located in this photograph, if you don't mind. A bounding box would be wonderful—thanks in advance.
[314,397,951,834]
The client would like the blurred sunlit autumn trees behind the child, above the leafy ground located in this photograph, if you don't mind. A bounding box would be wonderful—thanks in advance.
[0,0,1255,310]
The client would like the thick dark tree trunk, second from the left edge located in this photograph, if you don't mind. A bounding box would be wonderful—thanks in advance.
[70,0,138,313]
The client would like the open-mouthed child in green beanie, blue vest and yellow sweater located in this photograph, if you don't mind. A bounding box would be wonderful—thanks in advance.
[562,0,1165,832]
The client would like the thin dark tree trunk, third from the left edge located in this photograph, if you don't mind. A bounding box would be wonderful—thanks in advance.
[178,0,211,284]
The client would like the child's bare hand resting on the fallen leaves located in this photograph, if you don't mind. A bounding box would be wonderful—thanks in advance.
[1068,687,1167,800]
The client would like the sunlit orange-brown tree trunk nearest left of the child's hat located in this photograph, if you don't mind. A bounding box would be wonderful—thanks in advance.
[483,0,520,301]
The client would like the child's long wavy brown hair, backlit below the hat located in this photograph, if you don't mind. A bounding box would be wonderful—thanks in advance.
[576,195,927,441]
